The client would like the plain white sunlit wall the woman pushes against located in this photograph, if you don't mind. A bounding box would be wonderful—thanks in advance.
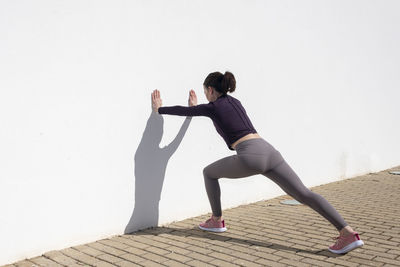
[0,0,400,264]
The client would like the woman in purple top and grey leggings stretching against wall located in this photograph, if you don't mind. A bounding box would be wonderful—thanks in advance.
[152,72,364,254]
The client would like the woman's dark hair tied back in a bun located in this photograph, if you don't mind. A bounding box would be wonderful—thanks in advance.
[203,71,236,95]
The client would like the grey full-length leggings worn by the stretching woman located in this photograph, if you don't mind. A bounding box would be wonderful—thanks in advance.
[203,138,347,231]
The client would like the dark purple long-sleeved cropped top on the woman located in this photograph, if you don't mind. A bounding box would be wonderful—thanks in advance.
[158,94,257,150]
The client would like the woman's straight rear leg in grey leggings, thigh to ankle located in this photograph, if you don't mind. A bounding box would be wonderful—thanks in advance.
[263,161,347,231]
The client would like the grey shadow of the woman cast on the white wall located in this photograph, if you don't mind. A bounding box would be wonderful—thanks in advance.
[124,111,192,234]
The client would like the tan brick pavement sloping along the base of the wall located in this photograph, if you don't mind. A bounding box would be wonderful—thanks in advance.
[6,166,400,267]
